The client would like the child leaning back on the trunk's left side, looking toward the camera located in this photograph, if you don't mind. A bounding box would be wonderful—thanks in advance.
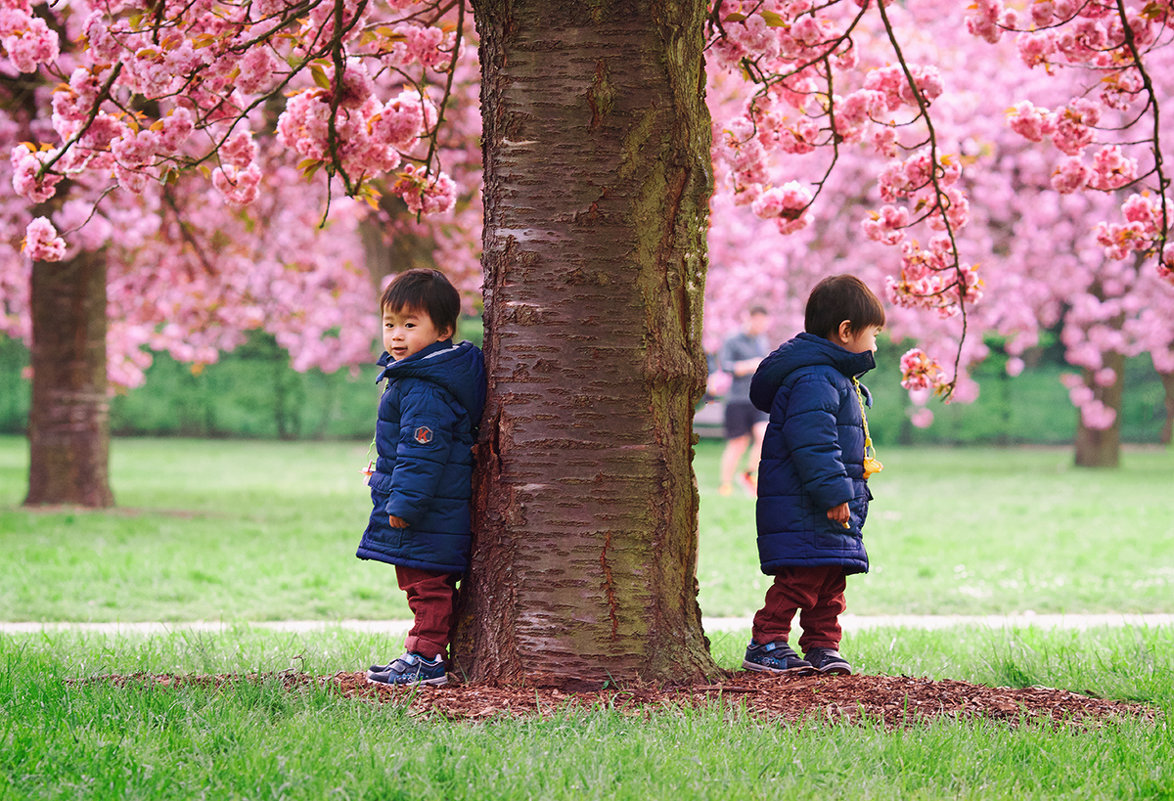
[356,269,485,685]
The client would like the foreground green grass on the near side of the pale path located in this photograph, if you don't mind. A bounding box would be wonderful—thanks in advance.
[0,628,1174,801]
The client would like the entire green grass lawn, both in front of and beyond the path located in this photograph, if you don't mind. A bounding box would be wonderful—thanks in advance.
[0,438,1174,801]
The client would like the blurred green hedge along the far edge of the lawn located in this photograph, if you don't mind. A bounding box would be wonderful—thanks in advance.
[0,319,1165,446]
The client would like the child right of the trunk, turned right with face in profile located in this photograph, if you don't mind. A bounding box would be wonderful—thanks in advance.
[742,275,885,675]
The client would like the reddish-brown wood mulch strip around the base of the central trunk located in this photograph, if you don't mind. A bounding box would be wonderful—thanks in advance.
[79,671,1160,728]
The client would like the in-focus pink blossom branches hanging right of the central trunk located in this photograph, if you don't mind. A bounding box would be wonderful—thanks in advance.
[709,0,1174,393]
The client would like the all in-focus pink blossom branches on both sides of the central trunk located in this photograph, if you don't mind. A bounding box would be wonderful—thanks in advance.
[0,0,1174,406]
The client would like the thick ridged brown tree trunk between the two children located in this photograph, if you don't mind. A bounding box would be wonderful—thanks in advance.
[456,0,713,686]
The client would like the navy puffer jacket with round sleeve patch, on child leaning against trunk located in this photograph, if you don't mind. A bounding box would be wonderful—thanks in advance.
[356,339,485,573]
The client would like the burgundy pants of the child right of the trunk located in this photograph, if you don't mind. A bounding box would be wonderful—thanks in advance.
[751,565,848,652]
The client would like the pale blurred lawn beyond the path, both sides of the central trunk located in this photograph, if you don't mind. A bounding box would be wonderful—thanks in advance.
[0,437,1174,621]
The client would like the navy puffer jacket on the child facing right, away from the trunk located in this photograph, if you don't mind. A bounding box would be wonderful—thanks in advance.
[750,334,876,574]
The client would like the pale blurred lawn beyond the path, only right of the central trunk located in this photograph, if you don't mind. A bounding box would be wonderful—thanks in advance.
[696,446,1174,615]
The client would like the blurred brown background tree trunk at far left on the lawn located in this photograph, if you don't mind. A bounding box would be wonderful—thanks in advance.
[25,247,114,507]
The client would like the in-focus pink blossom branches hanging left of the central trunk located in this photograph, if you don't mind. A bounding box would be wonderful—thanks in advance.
[0,0,464,261]
